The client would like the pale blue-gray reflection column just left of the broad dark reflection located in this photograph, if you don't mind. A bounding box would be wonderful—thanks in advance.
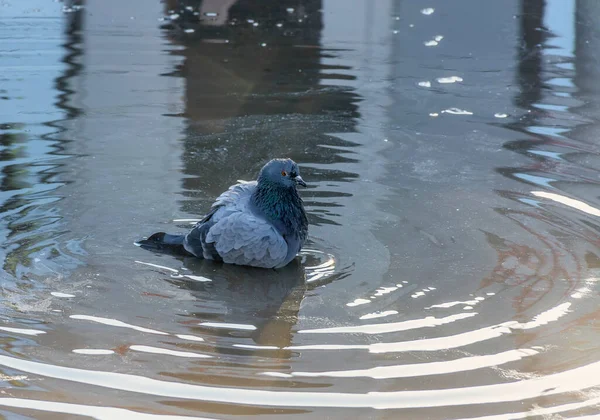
[52,0,183,252]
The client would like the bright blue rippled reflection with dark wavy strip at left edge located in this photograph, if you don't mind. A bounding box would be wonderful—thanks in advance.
[0,2,83,280]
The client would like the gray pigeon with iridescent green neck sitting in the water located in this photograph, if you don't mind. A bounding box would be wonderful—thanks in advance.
[137,159,308,268]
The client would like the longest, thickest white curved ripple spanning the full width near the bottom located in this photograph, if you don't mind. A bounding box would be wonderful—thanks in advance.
[0,356,600,409]
